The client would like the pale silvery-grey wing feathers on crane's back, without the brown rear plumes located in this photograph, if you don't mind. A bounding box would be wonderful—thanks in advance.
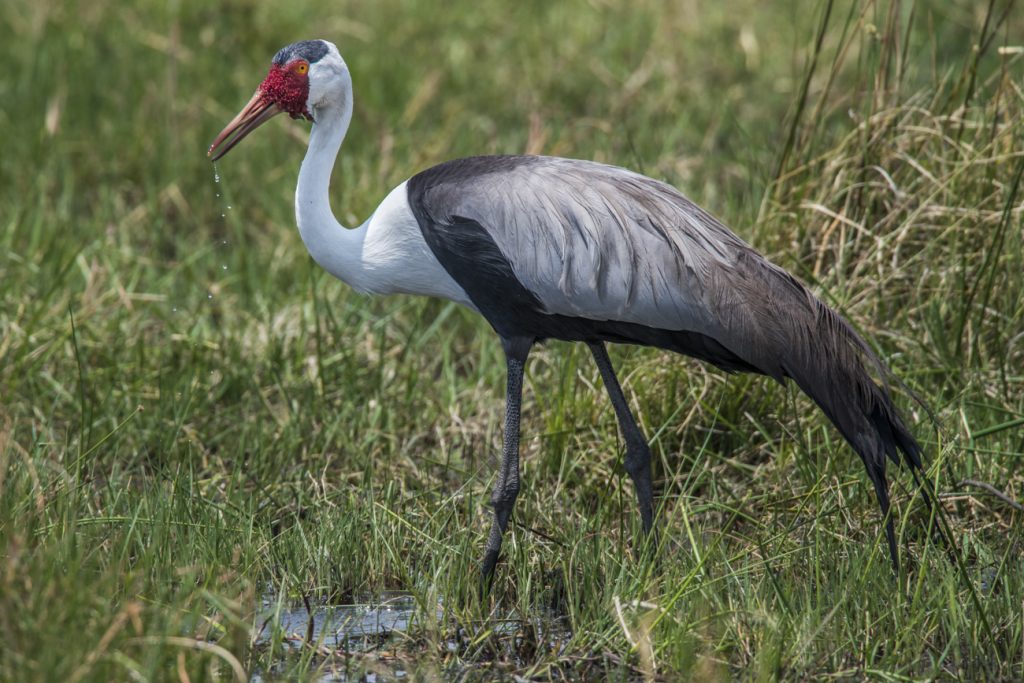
[419,157,753,330]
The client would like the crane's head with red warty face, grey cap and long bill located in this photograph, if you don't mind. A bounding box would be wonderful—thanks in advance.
[207,40,351,161]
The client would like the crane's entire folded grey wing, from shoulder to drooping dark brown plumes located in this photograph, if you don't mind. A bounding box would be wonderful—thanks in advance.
[411,157,920,478]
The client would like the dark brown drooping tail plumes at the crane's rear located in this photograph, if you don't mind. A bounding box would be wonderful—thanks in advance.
[708,251,925,570]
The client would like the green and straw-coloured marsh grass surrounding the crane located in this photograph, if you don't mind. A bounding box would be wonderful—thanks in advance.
[0,0,1024,681]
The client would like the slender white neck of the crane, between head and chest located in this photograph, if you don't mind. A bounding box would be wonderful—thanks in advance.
[295,98,367,290]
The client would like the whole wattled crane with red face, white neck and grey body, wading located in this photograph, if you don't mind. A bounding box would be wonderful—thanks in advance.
[209,40,922,580]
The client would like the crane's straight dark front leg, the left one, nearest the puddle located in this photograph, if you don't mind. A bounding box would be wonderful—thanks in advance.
[480,338,534,591]
